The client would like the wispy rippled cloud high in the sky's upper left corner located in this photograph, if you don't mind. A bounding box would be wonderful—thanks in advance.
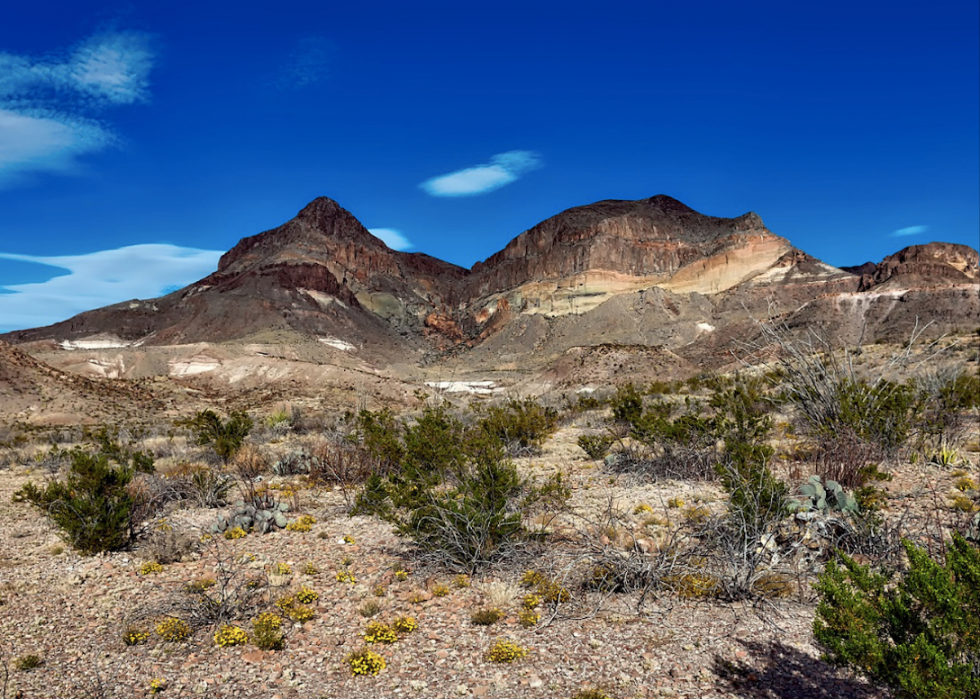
[0,31,155,187]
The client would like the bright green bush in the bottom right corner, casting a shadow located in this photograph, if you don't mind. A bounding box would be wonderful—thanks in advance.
[813,535,980,699]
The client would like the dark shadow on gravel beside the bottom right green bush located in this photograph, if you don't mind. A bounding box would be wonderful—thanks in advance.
[712,640,890,699]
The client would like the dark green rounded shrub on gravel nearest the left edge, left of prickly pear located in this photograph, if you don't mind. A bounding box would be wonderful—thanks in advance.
[14,432,153,554]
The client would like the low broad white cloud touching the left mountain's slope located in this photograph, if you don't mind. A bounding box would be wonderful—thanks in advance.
[0,244,222,332]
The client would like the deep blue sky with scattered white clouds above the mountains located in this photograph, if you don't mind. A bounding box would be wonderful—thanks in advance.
[0,0,980,331]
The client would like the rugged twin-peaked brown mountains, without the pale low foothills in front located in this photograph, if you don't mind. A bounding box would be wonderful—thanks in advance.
[0,195,980,366]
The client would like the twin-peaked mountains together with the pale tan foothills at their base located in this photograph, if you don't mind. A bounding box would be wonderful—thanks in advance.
[0,195,980,419]
